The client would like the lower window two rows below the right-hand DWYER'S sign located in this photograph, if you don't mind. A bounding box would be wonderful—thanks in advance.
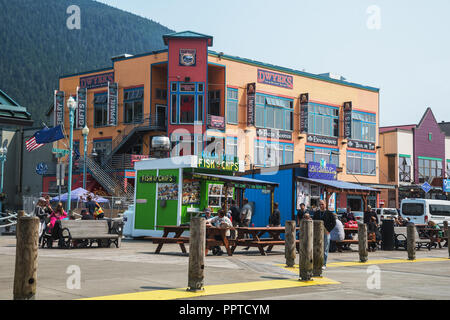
[255,140,294,167]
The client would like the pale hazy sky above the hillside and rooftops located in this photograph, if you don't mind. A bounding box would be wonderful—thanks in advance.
[98,0,450,126]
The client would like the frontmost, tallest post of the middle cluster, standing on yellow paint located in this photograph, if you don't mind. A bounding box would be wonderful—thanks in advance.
[299,219,313,281]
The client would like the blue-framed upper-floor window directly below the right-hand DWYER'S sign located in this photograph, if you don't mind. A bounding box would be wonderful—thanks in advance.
[255,94,294,131]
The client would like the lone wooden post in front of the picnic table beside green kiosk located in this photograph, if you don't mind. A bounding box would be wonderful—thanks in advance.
[187,217,206,291]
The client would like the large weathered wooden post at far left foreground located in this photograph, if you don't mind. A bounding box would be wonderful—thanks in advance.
[13,216,39,300]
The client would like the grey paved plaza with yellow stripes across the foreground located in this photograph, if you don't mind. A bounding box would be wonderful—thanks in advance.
[0,236,450,300]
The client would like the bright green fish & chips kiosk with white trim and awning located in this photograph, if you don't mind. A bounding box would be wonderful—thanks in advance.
[132,156,278,237]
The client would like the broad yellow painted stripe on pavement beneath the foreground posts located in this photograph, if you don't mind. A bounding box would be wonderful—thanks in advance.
[81,277,340,300]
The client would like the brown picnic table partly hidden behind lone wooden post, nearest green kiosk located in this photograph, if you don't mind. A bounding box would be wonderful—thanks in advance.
[151,225,233,256]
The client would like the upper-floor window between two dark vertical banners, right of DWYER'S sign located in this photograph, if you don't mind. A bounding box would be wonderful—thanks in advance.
[308,103,339,138]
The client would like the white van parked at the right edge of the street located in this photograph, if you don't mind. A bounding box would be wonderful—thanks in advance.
[400,199,450,226]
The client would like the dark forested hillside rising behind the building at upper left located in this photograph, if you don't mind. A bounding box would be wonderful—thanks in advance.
[0,0,173,126]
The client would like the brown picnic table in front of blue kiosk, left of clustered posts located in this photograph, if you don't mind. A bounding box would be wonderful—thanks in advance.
[231,227,299,256]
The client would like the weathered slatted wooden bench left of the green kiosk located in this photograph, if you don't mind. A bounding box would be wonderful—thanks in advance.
[42,220,122,248]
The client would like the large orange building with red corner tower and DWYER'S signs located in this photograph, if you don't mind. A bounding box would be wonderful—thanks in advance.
[55,31,379,209]
